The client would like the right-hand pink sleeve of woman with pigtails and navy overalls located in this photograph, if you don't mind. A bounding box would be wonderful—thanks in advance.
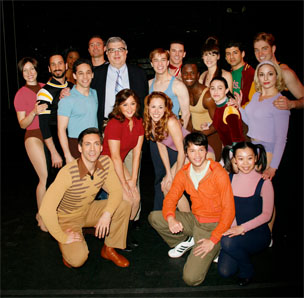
[242,180,274,232]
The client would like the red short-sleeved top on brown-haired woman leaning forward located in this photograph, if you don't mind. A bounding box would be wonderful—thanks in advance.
[101,117,144,161]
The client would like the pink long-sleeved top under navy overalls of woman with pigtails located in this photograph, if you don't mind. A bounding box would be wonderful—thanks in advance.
[231,170,274,232]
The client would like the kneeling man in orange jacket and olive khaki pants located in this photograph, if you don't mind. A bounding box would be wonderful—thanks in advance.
[149,132,235,286]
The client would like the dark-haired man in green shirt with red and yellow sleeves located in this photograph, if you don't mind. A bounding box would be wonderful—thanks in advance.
[225,40,254,106]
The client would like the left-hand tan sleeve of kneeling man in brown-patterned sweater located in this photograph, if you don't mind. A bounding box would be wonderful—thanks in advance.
[39,167,72,243]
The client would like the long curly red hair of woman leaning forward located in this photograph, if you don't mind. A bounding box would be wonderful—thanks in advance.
[143,91,176,142]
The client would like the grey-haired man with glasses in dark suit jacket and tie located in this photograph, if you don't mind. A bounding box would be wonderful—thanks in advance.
[91,37,149,130]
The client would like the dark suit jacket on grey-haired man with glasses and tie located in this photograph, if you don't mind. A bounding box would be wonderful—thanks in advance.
[91,64,149,131]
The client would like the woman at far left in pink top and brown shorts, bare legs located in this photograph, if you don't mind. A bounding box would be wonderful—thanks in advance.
[14,57,48,232]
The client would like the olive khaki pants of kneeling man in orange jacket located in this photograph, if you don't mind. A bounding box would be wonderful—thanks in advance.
[148,211,220,286]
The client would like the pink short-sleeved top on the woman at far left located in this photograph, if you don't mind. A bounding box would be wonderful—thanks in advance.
[14,83,44,130]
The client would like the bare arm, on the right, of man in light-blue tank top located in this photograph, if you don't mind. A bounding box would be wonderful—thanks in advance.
[172,80,190,128]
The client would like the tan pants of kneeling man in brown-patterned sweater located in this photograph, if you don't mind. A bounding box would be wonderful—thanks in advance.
[58,200,131,267]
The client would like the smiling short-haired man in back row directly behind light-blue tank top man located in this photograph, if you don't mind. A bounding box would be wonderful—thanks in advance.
[168,40,186,80]
